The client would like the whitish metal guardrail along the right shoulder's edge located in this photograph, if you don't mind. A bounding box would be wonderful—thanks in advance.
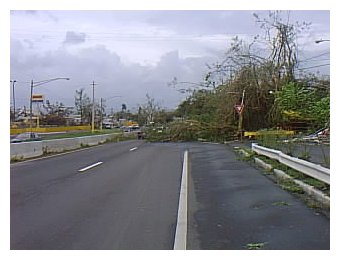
[251,143,330,184]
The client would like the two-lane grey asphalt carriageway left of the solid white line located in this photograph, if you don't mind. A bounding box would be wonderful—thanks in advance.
[11,141,183,249]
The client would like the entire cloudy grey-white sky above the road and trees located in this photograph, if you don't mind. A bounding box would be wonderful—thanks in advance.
[10,10,330,111]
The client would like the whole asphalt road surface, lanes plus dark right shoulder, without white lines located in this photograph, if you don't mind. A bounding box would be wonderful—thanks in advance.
[11,141,329,250]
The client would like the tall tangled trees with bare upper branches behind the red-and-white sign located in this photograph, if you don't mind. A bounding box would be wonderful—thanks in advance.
[171,12,329,138]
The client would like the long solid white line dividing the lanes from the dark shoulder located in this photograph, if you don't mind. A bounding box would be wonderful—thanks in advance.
[174,151,189,250]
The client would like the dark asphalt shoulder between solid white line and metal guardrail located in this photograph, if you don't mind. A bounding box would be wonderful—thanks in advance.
[187,144,330,250]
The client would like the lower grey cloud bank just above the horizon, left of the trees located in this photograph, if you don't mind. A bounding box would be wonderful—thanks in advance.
[11,45,211,109]
